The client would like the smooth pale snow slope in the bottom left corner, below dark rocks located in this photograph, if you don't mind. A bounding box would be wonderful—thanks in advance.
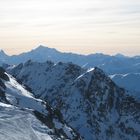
[0,103,53,140]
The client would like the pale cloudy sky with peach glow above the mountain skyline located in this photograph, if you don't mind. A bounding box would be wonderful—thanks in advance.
[0,0,140,55]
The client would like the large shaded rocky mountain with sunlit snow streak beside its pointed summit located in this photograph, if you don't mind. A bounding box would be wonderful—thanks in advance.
[9,60,140,140]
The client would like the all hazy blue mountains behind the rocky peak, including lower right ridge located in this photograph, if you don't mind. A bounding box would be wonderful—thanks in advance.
[0,46,140,97]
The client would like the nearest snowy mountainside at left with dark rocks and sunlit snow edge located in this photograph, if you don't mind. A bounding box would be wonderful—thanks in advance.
[0,68,80,140]
